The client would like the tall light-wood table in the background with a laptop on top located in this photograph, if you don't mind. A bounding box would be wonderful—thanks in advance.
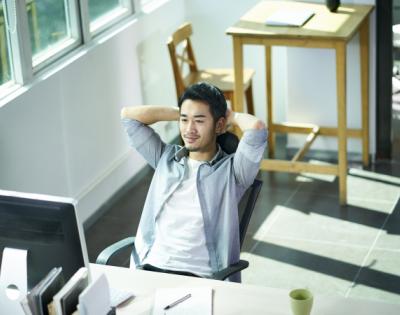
[226,1,373,204]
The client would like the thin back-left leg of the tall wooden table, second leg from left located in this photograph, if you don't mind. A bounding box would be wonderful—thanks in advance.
[265,46,275,159]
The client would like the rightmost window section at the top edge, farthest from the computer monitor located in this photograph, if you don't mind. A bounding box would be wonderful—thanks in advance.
[88,0,133,34]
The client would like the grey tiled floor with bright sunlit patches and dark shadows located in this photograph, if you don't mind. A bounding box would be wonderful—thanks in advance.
[86,144,400,303]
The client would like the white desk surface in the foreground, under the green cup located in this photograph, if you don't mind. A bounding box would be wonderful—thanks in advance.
[90,264,400,315]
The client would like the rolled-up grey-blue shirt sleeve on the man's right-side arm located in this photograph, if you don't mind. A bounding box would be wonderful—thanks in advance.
[233,128,267,188]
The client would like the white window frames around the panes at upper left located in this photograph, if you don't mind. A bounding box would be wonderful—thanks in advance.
[0,0,141,95]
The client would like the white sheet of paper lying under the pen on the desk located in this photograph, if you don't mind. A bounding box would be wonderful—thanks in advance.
[153,287,212,315]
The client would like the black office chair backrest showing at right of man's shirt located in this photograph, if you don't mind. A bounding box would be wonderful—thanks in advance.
[239,179,263,248]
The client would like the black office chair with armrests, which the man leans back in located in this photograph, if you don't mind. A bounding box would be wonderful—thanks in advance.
[96,179,262,280]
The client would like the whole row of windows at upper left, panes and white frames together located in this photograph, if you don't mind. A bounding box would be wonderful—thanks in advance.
[0,0,136,92]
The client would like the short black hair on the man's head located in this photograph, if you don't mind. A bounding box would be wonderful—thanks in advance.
[178,82,227,123]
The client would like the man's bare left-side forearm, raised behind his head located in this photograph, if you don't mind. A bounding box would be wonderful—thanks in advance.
[121,105,179,125]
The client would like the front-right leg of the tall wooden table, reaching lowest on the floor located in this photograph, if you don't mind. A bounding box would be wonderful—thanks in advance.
[336,42,347,205]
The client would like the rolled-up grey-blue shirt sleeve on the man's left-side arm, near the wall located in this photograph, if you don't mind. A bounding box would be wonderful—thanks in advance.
[122,118,165,168]
